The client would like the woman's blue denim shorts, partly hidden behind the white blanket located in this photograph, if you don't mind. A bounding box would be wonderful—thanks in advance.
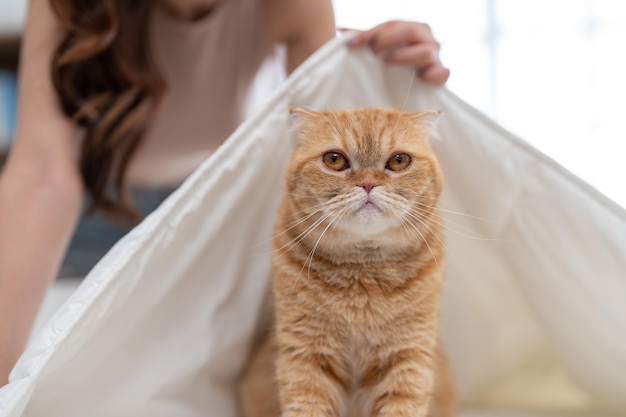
[59,188,176,278]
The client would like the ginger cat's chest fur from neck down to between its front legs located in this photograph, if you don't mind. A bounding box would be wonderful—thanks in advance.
[275,256,441,408]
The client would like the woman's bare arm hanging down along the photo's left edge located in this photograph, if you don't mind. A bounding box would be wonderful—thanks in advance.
[0,0,82,386]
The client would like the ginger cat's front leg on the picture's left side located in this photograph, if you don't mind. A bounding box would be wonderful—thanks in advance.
[276,347,346,417]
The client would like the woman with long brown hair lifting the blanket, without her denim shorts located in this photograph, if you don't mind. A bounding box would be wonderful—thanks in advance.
[0,0,449,385]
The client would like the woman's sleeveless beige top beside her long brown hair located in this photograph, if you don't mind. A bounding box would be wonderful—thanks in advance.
[129,0,272,186]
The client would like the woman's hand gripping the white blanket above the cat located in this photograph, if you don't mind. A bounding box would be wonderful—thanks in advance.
[348,21,450,85]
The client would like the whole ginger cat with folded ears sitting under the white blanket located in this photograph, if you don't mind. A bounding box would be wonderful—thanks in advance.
[240,108,456,417]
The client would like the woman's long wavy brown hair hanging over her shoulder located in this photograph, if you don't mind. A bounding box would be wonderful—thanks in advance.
[50,0,164,222]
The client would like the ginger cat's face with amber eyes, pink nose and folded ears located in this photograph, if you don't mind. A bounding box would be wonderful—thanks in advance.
[287,108,443,240]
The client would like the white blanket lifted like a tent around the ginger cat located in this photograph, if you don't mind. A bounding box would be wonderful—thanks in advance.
[0,40,626,417]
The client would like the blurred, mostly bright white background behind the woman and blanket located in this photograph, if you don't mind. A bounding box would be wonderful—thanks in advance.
[0,0,626,207]
